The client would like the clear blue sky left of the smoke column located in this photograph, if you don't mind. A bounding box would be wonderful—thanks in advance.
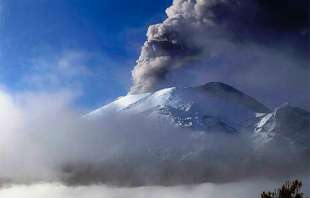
[0,0,171,108]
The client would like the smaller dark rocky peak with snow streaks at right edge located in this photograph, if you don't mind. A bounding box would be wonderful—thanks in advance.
[254,104,310,148]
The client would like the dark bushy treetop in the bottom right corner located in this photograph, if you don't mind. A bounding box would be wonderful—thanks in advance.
[261,180,304,198]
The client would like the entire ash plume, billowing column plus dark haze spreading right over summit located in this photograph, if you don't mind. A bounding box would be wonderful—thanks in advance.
[131,0,310,107]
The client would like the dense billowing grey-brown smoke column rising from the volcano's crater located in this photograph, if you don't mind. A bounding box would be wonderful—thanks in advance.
[131,0,210,93]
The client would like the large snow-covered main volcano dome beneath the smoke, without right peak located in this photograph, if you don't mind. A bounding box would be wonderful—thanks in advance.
[86,82,270,133]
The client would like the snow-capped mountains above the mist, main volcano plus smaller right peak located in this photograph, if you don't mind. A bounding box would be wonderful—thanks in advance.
[85,82,310,145]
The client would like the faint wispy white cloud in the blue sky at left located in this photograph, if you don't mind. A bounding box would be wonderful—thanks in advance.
[22,50,92,88]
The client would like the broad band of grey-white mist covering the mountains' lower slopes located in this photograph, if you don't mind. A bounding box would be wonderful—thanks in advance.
[0,87,310,186]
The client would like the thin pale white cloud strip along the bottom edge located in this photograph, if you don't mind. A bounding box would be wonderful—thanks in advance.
[0,177,310,198]
